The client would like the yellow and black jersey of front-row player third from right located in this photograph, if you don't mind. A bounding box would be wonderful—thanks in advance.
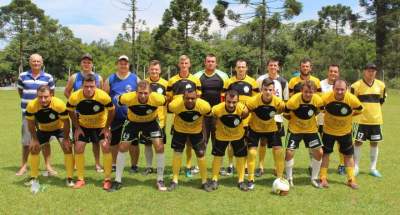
[246,93,285,132]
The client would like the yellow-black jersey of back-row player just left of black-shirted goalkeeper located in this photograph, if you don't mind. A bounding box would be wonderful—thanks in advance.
[167,74,201,100]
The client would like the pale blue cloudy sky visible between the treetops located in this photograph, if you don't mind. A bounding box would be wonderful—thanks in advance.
[0,0,363,49]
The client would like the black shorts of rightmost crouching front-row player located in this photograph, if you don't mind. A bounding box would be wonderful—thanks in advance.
[322,133,354,155]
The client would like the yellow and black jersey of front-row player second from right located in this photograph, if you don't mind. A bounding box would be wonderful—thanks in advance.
[285,93,324,134]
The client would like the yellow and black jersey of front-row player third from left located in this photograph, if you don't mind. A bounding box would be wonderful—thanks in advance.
[118,92,166,122]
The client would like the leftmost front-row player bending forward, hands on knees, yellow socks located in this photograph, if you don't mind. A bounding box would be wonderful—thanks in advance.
[26,85,74,187]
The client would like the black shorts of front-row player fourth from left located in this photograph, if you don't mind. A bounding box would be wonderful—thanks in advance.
[171,130,205,152]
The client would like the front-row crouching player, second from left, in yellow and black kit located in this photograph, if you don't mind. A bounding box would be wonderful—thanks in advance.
[67,74,115,190]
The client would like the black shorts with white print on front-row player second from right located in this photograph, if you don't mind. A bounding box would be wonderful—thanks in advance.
[286,130,322,150]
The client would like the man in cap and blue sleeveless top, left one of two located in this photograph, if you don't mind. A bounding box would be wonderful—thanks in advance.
[64,53,104,172]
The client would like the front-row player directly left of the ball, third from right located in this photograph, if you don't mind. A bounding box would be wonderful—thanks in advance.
[246,78,285,190]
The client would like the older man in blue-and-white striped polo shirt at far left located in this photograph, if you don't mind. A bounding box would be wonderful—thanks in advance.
[16,54,57,176]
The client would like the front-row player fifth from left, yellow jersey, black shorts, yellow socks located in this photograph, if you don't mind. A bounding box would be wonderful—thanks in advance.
[211,90,249,191]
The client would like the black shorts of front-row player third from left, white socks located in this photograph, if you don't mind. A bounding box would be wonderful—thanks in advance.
[121,120,162,145]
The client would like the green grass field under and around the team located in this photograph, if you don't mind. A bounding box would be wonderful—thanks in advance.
[0,91,400,214]
